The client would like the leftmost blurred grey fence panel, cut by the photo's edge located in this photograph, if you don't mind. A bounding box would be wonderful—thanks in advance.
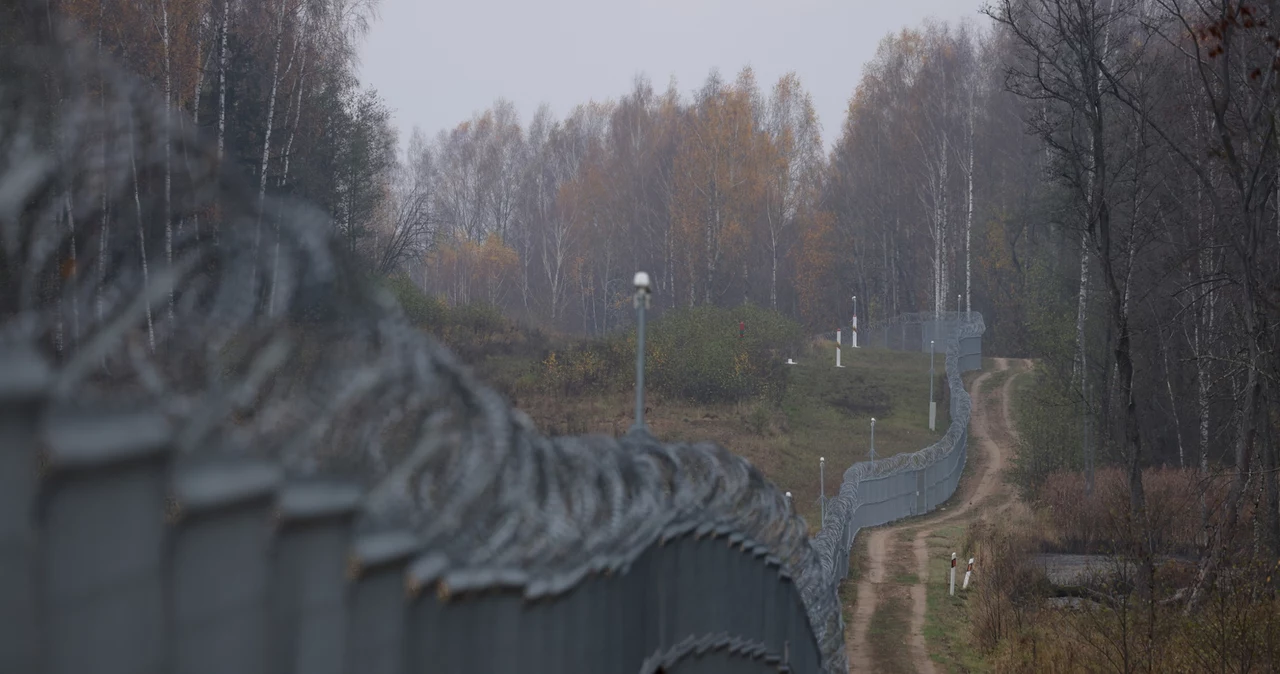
[0,347,50,671]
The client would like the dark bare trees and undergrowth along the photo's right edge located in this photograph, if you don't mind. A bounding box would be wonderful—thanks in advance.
[977,0,1280,671]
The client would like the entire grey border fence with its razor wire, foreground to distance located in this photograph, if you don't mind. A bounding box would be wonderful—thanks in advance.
[0,6,982,674]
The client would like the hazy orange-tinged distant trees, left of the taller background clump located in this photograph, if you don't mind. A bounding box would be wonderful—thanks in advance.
[408,69,823,334]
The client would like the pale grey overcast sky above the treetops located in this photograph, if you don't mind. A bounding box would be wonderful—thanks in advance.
[361,0,986,147]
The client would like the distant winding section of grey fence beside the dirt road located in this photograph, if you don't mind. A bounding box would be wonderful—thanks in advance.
[801,312,986,670]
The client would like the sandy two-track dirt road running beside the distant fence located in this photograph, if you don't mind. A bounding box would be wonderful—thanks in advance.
[847,358,1029,674]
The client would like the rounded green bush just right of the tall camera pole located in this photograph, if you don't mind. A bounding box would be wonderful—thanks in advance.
[645,304,801,403]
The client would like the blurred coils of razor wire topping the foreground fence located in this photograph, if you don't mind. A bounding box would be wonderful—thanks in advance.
[0,13,846,671]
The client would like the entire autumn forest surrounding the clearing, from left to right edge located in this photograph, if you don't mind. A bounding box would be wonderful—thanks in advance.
[15,0,1280,670]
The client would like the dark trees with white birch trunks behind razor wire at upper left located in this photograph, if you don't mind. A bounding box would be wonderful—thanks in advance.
[50,0,401,274]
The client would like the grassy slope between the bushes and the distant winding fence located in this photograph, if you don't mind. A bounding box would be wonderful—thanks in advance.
[477,341,950,531]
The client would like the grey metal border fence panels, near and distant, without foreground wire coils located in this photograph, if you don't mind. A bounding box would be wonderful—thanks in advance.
[0,316,983,674]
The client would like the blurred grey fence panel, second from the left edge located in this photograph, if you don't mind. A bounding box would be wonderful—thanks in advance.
[35,407,172,674]
